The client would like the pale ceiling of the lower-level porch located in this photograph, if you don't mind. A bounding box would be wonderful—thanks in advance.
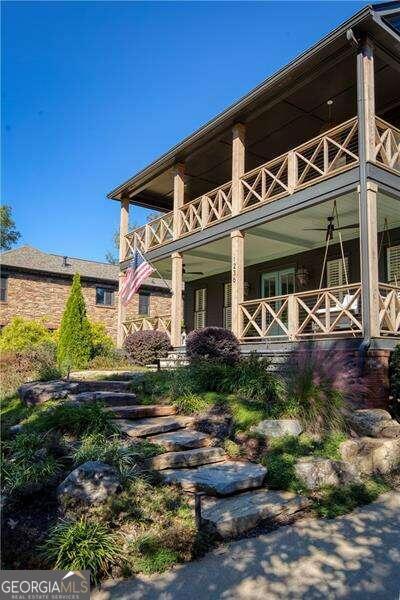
[155,192,400,281]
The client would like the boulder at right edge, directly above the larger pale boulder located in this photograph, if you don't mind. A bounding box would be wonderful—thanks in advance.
[348,408,400,438]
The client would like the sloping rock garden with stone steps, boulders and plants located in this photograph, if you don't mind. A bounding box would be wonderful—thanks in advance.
[2,328,400,583]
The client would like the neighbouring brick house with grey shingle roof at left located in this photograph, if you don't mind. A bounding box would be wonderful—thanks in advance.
[0,246,170,340]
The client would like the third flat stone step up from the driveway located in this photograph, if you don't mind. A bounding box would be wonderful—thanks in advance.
[149,447,226,471]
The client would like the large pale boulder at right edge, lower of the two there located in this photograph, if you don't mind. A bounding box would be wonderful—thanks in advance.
[339,437,400,475]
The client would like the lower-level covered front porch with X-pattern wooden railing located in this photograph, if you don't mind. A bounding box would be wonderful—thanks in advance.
[125,187,400,348]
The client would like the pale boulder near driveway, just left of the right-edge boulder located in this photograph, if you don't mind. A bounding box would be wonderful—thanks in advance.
[295,456,359,490]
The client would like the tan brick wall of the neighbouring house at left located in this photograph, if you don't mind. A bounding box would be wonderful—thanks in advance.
[0,273,171,339]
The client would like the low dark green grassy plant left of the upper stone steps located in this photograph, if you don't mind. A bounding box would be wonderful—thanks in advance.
[23,402,118,436]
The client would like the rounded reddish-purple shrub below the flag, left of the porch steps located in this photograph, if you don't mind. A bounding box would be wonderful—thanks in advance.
[124,330,171,365]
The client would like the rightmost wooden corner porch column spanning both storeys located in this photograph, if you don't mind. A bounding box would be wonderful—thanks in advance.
[357,38,380,340]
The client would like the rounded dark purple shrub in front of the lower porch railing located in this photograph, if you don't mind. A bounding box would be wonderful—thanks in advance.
[186,327,240,365]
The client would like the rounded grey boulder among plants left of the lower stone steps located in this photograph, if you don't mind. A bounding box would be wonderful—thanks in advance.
[57,460,121,504]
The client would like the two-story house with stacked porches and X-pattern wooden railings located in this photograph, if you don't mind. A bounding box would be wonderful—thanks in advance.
[108,1,400,398]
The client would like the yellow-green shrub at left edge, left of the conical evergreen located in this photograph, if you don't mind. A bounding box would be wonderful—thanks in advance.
[0,317,52,352]
